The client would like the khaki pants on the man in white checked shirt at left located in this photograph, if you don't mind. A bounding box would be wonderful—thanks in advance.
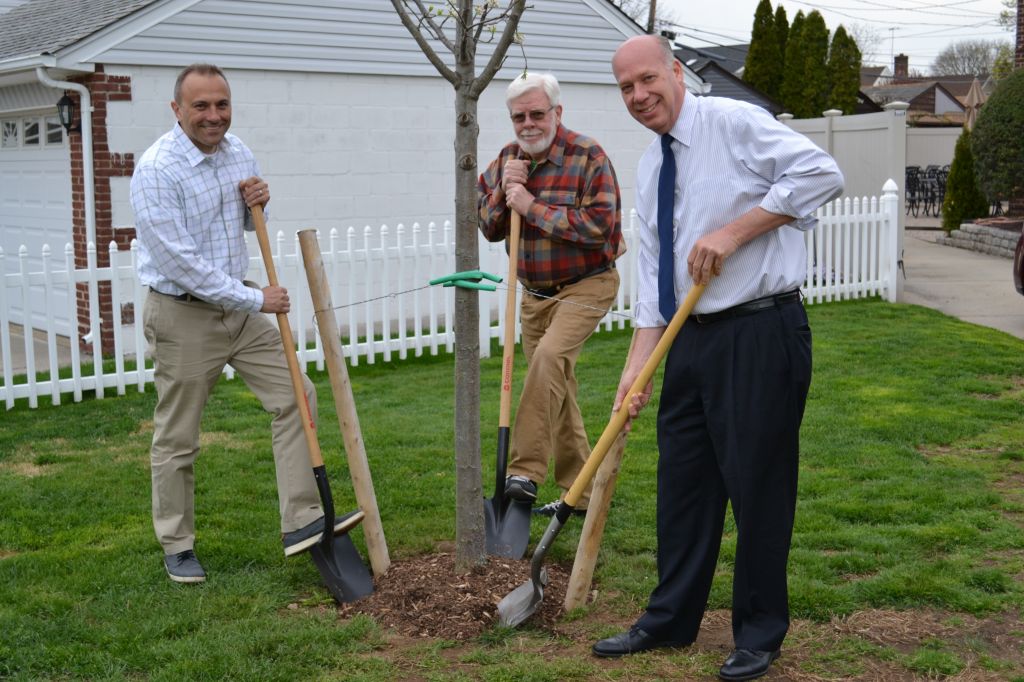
[143,292,323,554]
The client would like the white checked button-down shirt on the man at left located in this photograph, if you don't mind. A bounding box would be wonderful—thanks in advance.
[131,125,263,312]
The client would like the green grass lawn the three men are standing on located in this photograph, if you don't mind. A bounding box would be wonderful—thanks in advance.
[0,301,1024,680]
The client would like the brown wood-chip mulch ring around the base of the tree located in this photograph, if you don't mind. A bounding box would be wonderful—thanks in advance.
[338,552,569,641]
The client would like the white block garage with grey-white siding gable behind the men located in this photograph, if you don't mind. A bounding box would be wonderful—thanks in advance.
[0,0,703,346]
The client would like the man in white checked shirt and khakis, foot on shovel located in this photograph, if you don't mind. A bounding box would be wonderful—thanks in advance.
[131,65,343,583]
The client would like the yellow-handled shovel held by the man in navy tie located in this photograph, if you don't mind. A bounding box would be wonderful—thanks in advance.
[498,278,705,628]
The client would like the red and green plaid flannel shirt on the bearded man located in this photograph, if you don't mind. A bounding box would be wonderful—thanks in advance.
[477,125,623,289]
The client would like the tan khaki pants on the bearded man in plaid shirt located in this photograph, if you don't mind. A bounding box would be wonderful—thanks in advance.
[508,269,618,509]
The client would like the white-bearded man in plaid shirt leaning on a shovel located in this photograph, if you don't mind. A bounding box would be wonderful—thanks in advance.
[477,74,623,516]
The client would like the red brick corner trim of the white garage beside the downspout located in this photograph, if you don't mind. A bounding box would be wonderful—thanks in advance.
[68,67,135,353]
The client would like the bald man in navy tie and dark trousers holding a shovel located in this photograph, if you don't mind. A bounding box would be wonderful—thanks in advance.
[593,36,843,680]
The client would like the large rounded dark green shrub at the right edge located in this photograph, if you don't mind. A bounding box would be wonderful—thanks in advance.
[971,69,1024,215]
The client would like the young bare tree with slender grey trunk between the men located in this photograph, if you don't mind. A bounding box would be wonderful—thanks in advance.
[391,0,526,572]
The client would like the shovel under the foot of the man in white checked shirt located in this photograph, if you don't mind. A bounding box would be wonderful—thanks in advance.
[252,205,374,602]
